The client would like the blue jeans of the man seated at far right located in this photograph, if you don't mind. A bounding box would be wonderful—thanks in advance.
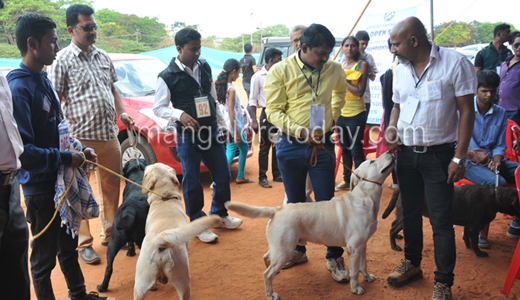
[464,159,520,187]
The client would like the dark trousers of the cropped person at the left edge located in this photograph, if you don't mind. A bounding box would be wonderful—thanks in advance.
[0,177,31,300]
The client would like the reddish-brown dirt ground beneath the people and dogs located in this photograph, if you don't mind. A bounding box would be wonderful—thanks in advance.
[21,83,520,300]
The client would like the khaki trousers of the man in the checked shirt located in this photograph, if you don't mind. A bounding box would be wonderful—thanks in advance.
[78,138,121,251]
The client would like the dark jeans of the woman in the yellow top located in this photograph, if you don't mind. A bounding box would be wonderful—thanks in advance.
[336,112,367,183]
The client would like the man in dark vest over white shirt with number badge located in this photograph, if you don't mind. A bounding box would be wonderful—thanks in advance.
[153,28,242,243]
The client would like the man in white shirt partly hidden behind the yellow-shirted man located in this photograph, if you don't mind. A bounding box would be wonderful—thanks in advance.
[249,48,282,188]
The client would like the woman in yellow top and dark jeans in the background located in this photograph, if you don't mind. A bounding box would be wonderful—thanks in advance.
[336,36,368,191]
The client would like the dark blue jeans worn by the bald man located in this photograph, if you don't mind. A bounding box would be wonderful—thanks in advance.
[397,144,456,286]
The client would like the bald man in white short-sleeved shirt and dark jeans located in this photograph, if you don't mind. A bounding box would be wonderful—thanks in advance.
[386,17,477,299]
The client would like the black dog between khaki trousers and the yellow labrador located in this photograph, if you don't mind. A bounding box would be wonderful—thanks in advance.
[97,159,150,292]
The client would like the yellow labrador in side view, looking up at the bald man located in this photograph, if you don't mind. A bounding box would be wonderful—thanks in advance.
[226,152,395,300]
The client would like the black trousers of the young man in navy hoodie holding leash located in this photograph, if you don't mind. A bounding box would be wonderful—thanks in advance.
[25,193,86,300]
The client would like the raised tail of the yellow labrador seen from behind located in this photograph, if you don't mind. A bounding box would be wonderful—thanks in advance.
[156,215,221,246]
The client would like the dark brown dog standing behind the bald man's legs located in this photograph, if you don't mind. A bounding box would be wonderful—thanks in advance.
[383,184,520,257]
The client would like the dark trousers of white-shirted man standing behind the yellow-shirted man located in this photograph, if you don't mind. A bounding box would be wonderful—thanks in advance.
[258,108,281,180]
